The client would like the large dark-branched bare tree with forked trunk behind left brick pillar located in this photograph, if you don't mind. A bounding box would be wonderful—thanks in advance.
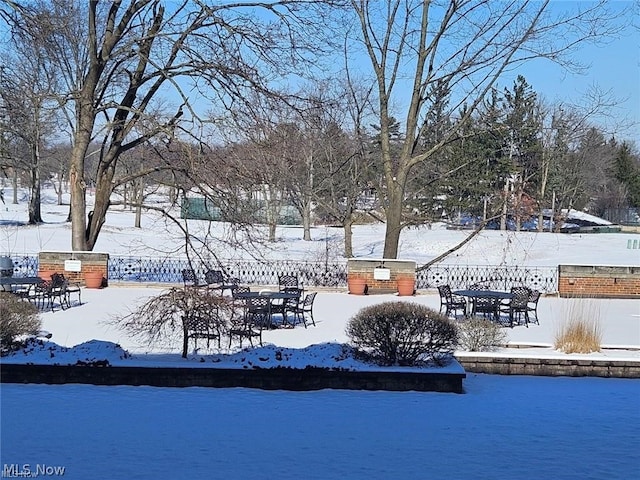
[5,0,330,250]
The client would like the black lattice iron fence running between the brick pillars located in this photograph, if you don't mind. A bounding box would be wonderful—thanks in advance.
[1,255,558,293]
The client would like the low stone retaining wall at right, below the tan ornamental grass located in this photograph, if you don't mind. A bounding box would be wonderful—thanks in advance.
[456,355,640,378]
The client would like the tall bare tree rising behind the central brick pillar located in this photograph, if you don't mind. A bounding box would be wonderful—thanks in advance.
[351,0,617,258]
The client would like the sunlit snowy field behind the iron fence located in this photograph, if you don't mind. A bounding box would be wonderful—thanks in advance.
[0,187,640,266]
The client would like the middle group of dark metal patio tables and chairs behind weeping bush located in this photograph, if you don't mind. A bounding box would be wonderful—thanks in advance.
[183,269,317,347]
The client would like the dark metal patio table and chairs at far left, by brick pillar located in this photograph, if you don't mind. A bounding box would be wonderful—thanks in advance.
[0,273,82,312]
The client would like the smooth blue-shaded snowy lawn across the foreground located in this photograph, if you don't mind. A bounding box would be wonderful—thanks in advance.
[0,375,640,480]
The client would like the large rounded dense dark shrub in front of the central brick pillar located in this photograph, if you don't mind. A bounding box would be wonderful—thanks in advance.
[346,302,458,365]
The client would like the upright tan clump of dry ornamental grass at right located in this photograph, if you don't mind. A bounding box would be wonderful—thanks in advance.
[554,298,602,353]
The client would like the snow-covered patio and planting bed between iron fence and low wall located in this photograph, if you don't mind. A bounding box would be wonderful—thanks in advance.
[3,286,640,373]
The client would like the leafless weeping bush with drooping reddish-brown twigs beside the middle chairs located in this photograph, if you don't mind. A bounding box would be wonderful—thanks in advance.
[115,288,233,357]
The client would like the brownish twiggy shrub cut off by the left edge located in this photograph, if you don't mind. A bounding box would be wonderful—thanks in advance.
[0,292,41,352]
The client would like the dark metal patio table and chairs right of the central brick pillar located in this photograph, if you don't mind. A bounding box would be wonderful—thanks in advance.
[438,284,540,327]
